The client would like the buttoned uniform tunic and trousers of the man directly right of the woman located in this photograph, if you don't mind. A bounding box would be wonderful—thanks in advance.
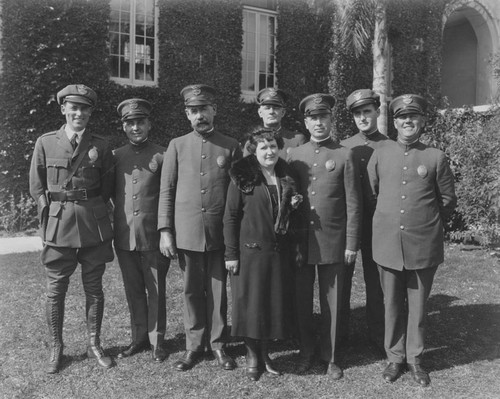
[288,138,362,362]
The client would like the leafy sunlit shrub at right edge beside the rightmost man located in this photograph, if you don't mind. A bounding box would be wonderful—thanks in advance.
[425,108,500,246]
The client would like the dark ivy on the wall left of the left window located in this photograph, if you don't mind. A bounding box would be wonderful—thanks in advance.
[0,0,109,203]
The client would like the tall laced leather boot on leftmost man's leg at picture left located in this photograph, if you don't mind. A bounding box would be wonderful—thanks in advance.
[45,297,64,374]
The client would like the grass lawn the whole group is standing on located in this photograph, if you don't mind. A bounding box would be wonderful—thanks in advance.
[0,246,500,399]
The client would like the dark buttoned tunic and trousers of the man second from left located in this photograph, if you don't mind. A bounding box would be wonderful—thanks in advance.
[114,140,170,347]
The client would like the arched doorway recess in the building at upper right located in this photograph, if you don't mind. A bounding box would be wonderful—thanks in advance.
[441,1,496,107]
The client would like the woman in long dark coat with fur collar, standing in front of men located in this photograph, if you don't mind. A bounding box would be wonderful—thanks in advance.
[224,128,302,381]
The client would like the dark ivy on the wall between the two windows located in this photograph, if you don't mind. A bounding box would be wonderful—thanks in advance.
[159,0,243,140]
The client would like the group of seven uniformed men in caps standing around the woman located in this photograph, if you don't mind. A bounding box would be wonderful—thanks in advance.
[30,84,456,386]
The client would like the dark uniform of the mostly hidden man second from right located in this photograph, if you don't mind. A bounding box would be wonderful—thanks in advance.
[339,131,388,348]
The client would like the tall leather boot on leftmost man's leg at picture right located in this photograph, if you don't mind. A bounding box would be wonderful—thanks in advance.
[86,297,113,369]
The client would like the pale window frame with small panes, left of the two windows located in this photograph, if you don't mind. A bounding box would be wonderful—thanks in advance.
[109,0,159,87]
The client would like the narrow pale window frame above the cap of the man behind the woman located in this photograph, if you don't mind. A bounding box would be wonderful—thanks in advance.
[241,5,278,103]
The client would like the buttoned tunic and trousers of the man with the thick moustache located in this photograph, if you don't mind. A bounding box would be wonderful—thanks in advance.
[158,131,241,351]
